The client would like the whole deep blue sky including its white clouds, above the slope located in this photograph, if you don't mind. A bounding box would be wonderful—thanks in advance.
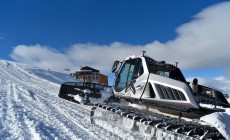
[0,0,230,84]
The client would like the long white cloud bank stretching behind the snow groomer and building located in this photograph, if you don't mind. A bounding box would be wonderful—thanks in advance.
[11,2,230,79]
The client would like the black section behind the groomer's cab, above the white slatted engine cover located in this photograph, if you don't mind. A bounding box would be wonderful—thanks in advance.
[146,58,186,82]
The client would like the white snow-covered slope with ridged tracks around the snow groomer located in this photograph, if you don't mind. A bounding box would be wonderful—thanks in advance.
[0,60,230,140]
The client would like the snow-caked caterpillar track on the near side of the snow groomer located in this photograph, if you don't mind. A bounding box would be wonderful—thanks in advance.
[90,104,225,140]
